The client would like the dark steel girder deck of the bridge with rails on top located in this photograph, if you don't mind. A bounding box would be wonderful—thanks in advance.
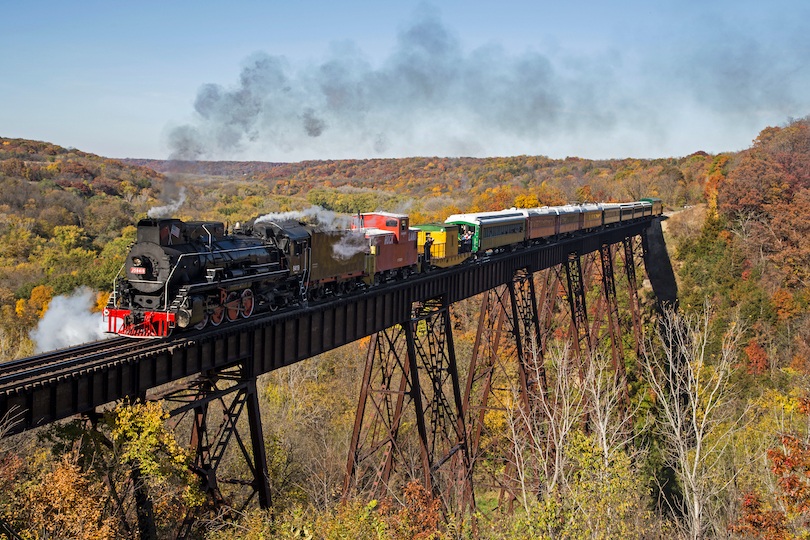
[0,221,650,432]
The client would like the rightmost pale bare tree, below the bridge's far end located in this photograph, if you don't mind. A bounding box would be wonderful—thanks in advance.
[644,306,745,540]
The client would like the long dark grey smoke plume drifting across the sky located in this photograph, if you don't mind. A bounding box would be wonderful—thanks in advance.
[168,6,810,161]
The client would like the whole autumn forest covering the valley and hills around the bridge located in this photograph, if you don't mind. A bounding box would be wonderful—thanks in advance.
[0,117,810,540]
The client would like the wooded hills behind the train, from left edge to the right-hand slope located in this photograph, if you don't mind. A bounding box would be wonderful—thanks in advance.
[0,134,735,360]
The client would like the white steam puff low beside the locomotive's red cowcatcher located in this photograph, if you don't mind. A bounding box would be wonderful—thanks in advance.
[29,287,110,353]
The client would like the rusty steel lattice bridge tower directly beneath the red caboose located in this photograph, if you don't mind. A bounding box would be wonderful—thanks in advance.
[343,297,474,511]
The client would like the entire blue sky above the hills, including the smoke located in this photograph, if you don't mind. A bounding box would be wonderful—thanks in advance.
[0,0,810,161]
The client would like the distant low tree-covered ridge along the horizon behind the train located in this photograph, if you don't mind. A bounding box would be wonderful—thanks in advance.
[128,152,720,208]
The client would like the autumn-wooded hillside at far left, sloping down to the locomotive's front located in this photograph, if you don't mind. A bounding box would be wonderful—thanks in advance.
[0,138,164,361]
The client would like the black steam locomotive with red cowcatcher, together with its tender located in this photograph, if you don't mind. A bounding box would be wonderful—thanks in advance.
[104,219,365,338]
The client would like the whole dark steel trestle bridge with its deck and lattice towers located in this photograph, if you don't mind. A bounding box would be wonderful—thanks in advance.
[0,219,660,536]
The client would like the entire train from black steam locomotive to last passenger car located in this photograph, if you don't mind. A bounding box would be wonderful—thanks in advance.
[104,199,663,338]
